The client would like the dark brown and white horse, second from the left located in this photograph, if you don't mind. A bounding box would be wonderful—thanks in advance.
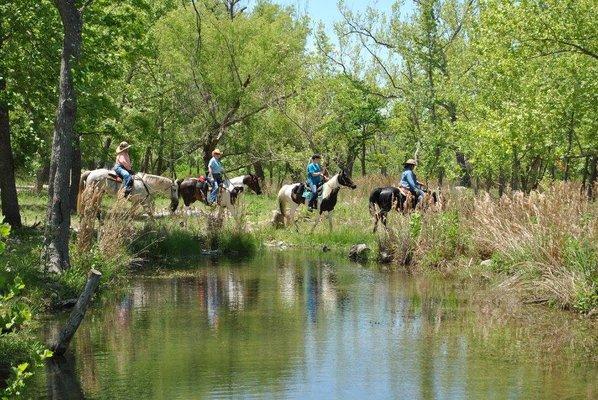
[175,174,262,216]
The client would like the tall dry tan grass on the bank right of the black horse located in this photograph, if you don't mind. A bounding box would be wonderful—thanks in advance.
[379,183,598,314]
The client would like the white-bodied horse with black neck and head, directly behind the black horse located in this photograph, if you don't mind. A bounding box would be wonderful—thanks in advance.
[278,171,357,232]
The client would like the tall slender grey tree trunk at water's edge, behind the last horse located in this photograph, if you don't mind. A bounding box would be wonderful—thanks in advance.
[43,0,83,273]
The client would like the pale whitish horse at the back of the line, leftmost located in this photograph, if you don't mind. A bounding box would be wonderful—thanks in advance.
[77,168,179,217]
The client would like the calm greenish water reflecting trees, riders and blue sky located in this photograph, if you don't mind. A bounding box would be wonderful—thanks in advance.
[37,253,598,399]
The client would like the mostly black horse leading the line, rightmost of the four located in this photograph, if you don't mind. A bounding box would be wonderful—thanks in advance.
[369,186,439,233]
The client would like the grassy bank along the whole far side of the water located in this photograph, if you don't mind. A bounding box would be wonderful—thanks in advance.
[0,178,598,396]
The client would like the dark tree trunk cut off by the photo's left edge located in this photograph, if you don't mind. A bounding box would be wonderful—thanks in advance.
[0,75,21,228]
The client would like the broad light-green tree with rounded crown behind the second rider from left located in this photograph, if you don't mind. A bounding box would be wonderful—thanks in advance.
[156,1,307,165]
